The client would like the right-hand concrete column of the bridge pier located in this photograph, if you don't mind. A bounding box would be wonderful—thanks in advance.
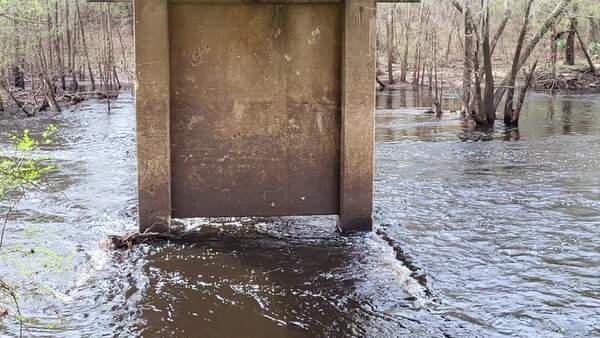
[338,0,376,232]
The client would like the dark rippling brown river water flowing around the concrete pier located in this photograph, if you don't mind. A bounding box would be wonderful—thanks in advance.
[0,92,600,337]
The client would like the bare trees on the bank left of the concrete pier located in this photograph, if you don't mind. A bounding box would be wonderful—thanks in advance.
[0,0,134,116]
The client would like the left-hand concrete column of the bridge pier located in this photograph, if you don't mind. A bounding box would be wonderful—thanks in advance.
[134,0,171,232]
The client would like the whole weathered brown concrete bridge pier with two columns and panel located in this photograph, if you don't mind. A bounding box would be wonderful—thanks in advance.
[135,0,375,231]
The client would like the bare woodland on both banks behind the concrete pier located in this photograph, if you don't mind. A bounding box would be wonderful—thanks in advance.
[0,0,600,126]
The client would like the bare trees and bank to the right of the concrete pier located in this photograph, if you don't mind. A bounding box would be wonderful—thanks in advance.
[377,0,600,127]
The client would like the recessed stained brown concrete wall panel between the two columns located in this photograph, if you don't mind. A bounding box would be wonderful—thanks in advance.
[170,3,342,217]
